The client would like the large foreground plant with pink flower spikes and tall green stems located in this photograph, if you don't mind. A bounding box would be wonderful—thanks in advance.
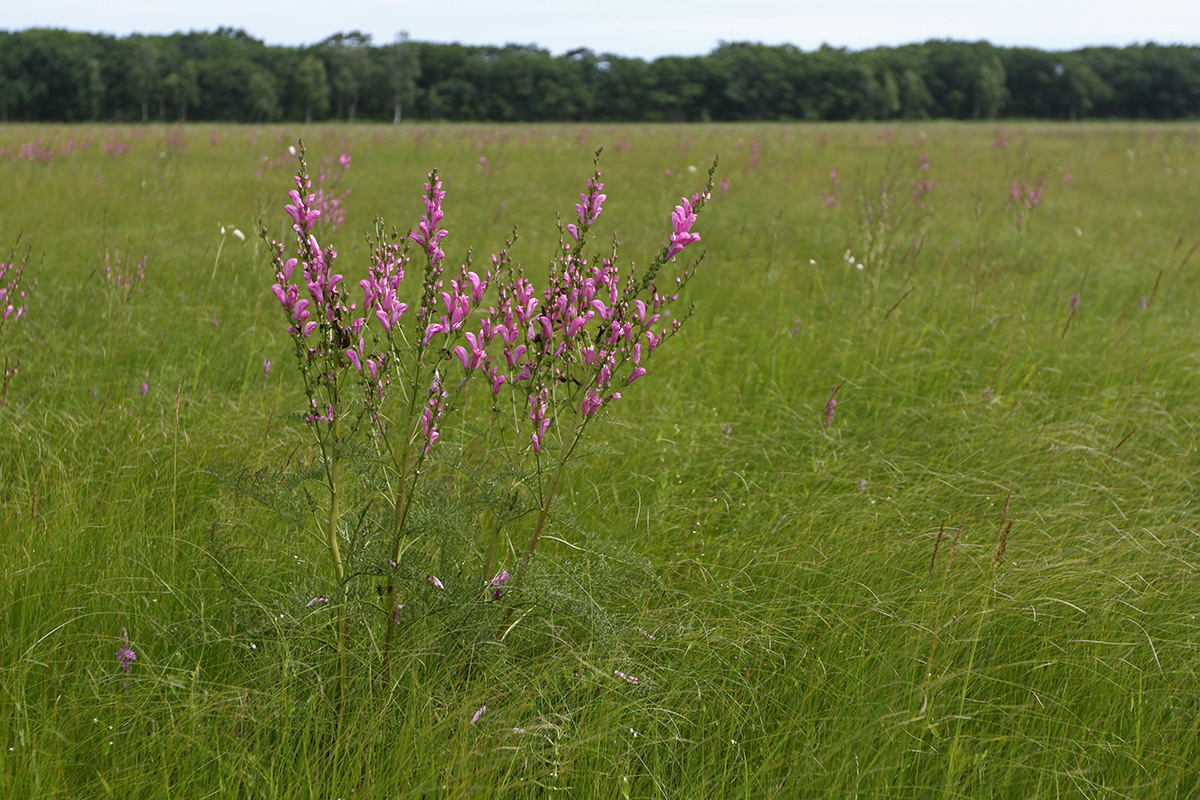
[263,144,715,669]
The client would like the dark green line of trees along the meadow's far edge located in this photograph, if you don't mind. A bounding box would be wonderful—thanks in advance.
[0,28,1200,122]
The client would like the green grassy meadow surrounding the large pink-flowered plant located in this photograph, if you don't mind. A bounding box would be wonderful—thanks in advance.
[0,122,1200,799]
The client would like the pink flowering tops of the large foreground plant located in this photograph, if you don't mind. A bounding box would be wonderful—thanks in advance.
[271,143,715,453]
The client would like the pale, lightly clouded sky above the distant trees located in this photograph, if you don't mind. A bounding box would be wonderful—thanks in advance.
[0,0,1200,59]
